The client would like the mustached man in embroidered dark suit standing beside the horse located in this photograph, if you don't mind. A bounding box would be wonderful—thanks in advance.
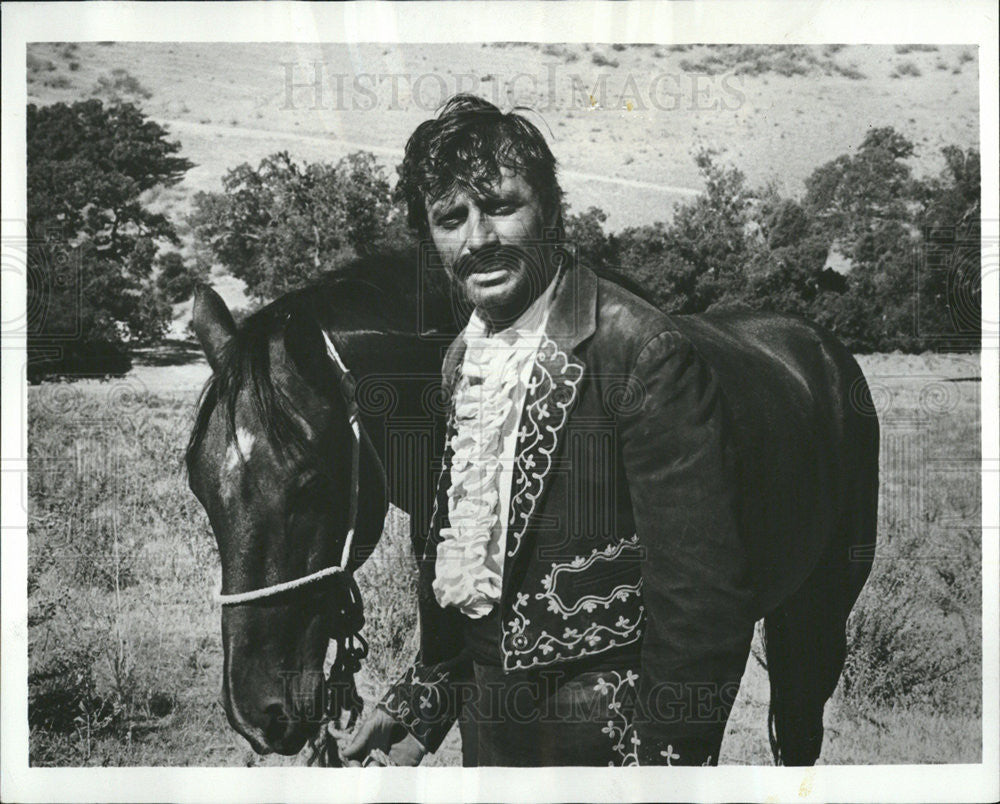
[344,95,755,766]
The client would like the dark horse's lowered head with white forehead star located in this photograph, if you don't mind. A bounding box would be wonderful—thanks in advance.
[187,289,387,754]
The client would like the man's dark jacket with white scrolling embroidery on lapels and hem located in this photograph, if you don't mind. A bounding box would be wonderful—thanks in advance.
[380,266,756,764]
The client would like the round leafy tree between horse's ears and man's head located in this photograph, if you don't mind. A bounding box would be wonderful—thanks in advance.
[189,151,408,300]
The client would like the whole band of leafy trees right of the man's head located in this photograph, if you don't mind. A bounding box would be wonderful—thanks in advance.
[565,128,981,351]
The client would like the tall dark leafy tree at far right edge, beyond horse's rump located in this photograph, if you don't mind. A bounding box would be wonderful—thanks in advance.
[804,128,981,351]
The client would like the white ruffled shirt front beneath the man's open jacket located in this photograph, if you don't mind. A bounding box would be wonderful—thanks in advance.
[433,279,556,618]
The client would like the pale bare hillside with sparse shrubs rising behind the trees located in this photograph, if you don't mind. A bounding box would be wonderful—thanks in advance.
[28,43,979,229]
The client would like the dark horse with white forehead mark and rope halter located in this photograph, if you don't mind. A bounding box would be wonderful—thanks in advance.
[187,255,878,764]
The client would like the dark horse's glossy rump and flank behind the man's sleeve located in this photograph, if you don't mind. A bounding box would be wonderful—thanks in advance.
[672,313,878,613]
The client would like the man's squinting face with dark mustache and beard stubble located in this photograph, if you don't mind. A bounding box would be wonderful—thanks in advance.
[427,168,555,326]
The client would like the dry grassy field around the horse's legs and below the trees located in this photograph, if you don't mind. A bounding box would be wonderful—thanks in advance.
[28,355,981,766]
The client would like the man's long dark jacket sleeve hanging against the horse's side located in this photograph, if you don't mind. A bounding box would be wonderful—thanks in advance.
[620,331,756,765]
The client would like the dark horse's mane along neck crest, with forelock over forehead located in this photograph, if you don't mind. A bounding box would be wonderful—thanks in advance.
[185,251,649,466]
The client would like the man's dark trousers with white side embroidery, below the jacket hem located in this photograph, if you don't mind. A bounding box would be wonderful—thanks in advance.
[460,662,638,766]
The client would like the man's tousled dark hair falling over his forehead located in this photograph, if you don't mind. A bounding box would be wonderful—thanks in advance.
[396,94,562,237]
